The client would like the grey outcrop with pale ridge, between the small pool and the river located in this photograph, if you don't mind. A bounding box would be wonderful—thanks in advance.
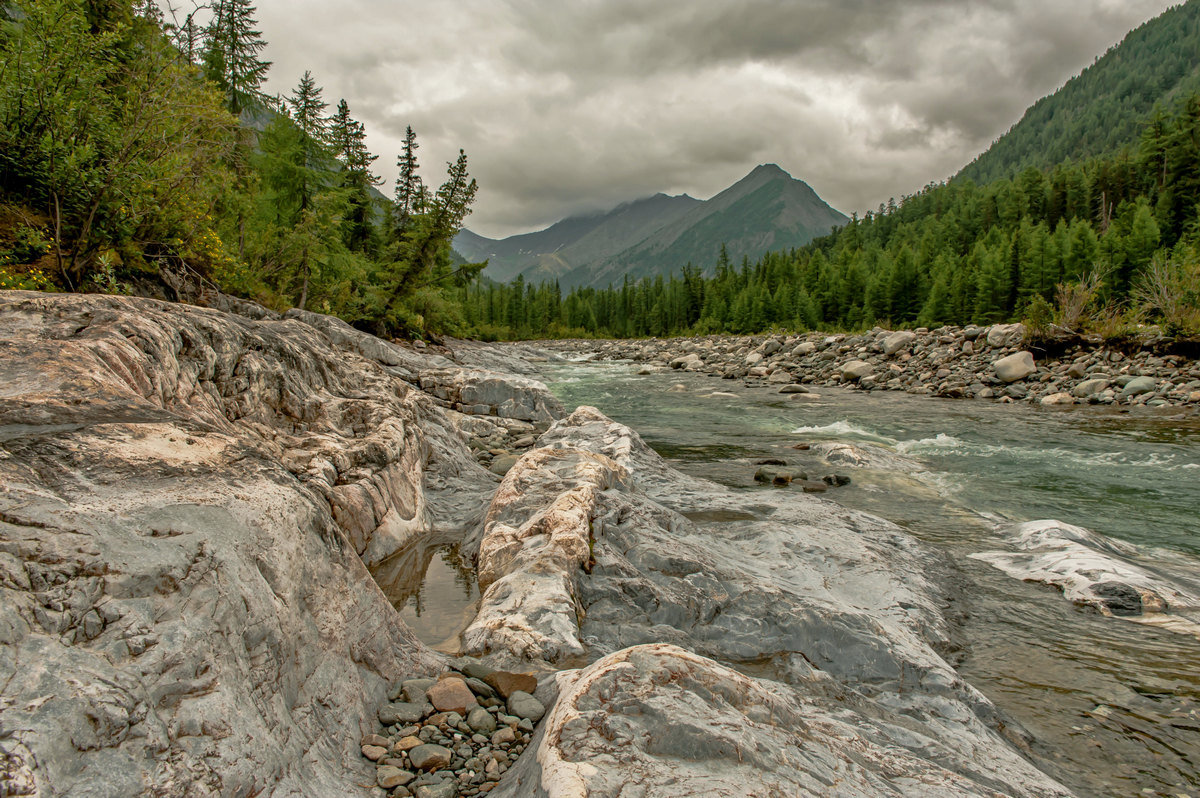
[470,407,1069,798]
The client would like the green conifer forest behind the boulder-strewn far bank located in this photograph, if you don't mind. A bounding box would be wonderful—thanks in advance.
[460,95,1200,337]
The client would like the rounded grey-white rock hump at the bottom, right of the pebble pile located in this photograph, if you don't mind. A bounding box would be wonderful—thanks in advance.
[492,644,1070,798]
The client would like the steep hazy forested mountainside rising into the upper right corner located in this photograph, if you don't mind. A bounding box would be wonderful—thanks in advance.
[958,0,1200,184]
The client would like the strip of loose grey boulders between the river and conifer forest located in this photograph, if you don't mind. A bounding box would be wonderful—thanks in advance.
[539,324,1200,407]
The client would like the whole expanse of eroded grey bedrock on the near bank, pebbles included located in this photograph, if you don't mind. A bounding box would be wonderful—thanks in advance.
[0,293,1084,797]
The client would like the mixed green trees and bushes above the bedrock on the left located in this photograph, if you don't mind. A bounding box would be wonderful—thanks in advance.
[0,0,482,334]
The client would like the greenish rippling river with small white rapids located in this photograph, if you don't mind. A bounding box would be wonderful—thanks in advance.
[544,364,1200,797]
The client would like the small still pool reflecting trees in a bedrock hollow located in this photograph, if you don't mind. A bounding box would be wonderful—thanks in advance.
[372,541,479,654]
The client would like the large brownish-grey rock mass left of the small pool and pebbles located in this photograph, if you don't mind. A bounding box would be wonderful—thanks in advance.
[0,292,554,796]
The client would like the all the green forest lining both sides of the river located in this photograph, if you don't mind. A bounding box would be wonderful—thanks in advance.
[0,0,1200,338]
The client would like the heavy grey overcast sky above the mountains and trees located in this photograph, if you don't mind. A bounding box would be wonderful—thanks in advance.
[211,0,1174,238]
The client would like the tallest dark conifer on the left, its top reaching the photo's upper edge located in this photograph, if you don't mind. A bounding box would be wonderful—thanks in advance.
[203,0,271,115]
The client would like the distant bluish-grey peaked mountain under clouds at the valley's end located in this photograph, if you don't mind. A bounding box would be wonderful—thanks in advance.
[455,163,847,288]
